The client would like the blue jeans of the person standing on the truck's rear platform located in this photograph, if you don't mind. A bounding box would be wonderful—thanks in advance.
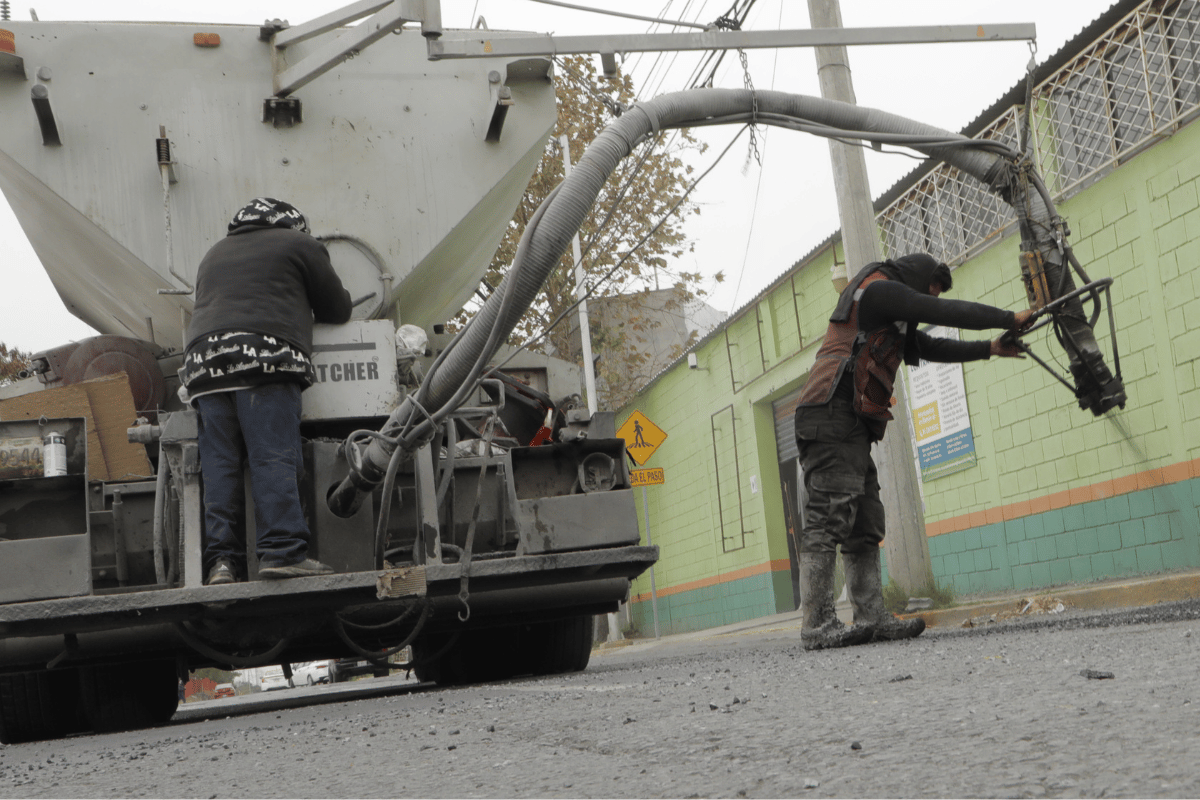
[196,383,308,575]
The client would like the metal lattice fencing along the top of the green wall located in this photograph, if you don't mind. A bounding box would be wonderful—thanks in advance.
[876,0,1200,264]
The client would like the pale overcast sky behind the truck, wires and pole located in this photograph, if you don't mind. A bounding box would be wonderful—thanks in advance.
[0,0,1111,350]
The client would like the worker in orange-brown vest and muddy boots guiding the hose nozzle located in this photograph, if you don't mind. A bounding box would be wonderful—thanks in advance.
[796,253,1032,650]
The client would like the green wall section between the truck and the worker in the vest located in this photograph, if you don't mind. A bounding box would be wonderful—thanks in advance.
[618,248,836,630]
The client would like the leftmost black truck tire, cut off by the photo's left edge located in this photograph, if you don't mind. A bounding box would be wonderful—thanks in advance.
[0,669,85,745]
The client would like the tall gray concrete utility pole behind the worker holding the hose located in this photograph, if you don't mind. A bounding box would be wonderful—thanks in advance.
[809,0,932,595]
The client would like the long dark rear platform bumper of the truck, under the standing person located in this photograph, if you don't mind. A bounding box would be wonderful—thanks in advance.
[0,546,658,670]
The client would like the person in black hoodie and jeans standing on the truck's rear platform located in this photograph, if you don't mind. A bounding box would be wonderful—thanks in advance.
[179,197,350,585]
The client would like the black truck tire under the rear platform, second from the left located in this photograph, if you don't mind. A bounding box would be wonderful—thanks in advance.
[79,660,179,733]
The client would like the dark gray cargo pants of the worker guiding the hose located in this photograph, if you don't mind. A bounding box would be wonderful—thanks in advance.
[796,397,883,553]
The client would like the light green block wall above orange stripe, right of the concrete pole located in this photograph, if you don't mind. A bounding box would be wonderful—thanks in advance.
[925,125,1200,537]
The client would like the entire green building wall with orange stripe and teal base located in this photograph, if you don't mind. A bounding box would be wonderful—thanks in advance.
[622,92,1200,632]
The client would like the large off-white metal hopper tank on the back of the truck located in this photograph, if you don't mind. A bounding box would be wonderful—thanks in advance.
[0,13,556,347]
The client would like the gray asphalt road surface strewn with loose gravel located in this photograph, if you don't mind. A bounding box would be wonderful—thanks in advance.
[0,601,1200,798]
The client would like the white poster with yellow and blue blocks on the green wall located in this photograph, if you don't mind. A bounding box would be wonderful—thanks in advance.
[907,326,976,481]
